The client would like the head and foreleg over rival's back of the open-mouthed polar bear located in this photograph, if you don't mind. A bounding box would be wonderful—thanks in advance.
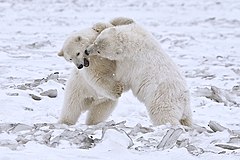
[58,17,134,69]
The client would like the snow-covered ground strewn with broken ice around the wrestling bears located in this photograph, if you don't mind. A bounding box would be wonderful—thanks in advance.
[0,0,240,160]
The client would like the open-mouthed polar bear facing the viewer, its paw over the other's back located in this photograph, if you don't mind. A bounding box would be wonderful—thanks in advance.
[58,17,132,125]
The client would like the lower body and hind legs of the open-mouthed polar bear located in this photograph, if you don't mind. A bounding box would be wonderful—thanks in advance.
[59,68,117,125]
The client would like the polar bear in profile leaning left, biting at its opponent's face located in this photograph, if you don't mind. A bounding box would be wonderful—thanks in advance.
[85,23,192,126]
